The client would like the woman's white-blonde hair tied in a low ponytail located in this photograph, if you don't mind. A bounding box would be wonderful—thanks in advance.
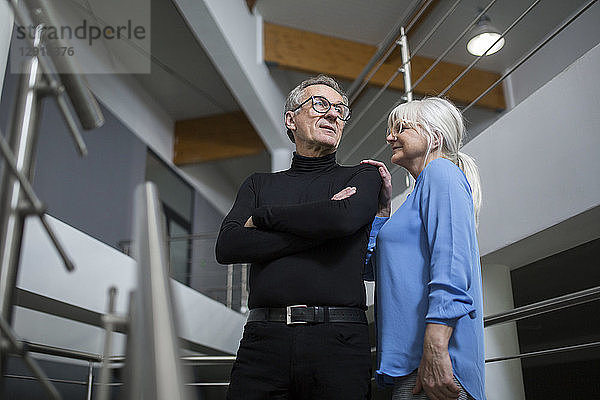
[388,97,481,223]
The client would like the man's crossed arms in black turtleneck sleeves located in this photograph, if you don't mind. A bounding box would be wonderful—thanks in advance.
[216,168,380,264]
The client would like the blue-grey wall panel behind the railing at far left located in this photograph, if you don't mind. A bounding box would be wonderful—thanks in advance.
[0,69,146,247]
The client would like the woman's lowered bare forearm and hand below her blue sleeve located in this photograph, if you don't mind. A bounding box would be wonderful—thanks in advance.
[413,324,460,400]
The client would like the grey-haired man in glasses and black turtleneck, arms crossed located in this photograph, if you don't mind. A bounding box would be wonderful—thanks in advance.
[216,75,381,400]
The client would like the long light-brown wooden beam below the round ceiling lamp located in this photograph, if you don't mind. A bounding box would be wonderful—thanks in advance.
[263,23,506,110]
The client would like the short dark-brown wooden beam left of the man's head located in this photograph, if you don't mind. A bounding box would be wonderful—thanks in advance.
[173,111,266,165]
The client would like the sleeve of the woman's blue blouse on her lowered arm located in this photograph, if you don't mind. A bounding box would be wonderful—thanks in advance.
[420,161,476,326]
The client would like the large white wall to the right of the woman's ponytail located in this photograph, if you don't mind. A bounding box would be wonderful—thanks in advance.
[464,42,600,255]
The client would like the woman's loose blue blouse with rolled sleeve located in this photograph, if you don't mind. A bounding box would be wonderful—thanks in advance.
[365,158,485,400]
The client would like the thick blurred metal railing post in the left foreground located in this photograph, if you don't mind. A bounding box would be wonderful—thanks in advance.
[124,182,189,400]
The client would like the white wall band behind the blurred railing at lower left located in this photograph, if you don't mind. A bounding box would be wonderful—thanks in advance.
[15,217,245,354]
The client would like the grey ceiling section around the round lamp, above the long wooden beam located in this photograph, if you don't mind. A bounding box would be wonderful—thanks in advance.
[256,0,586,72]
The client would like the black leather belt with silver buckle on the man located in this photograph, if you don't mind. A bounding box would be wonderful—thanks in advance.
[247,305,367,325]
